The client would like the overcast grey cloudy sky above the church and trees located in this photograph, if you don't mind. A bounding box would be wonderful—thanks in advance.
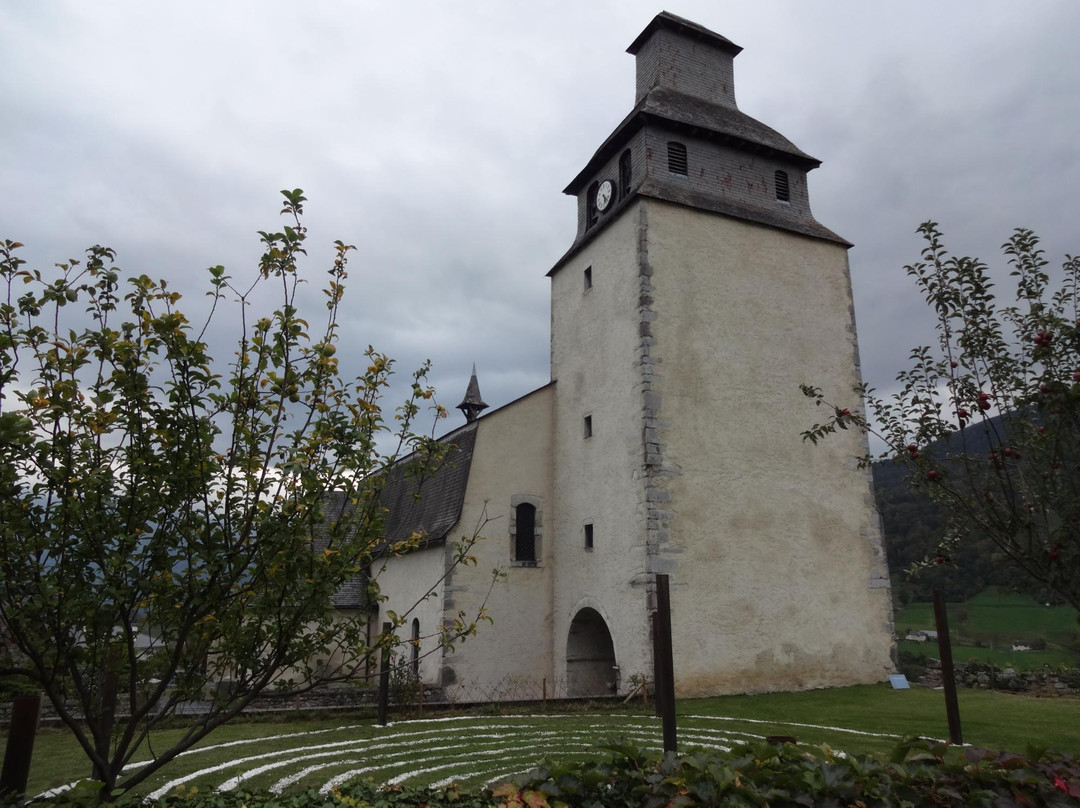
[0,0,1080,442]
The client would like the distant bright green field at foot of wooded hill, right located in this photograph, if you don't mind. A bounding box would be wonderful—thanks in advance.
[894,589,1080,670]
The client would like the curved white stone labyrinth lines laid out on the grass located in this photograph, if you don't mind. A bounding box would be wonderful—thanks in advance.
[111,715,897,799]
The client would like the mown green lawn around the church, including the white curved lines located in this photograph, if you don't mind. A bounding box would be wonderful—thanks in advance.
[16,685,1080,795]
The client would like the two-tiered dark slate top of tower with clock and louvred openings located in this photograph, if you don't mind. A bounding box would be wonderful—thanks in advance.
[549,12,850,274]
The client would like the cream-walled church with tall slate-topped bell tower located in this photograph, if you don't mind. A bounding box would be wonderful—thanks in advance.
[362,13,894,700]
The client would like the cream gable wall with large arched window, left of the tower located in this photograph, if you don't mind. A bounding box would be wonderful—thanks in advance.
[444,386,555,700]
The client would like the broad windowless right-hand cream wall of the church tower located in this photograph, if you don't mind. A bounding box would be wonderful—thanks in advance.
[647,200,892,695]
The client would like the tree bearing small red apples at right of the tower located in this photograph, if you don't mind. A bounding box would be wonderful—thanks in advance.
[802,221,1080,609]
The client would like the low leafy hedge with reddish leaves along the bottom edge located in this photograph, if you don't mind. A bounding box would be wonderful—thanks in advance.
[10,739,1080,808]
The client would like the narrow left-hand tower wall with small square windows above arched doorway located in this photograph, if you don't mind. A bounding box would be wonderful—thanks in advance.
[552,202,651,689]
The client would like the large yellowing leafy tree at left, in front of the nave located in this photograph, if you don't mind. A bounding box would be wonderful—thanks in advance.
[0,190,490,800]
